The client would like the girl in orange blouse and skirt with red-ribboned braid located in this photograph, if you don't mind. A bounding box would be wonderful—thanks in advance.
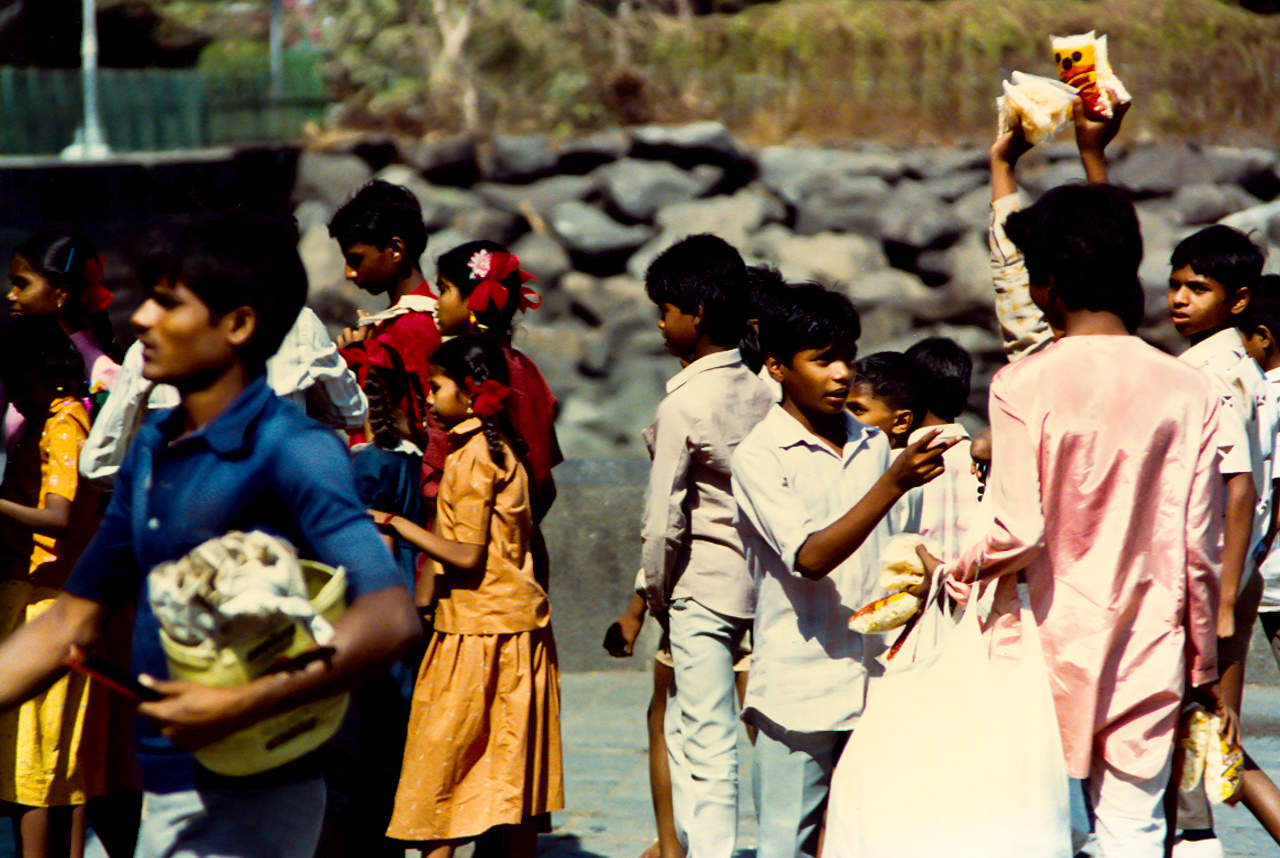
[372,334,564,858]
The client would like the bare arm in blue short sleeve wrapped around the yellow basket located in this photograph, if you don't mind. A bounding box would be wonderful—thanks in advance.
[138,587,422,750]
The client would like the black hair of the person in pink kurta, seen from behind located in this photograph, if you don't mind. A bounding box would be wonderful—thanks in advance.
[1005,184,1142,323]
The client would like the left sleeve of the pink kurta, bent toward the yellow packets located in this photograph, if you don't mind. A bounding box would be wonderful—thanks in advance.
[940,373,1044,601]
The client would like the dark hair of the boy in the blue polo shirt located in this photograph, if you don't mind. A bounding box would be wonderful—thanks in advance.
[168,211,307,373]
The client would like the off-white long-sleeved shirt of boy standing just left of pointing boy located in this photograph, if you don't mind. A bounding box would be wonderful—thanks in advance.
[640,348,773,617]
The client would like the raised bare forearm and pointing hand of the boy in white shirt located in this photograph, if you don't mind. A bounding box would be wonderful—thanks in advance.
[796,429,959,580]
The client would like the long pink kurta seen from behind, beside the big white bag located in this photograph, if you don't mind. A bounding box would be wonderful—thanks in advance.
[942,337,1222,777]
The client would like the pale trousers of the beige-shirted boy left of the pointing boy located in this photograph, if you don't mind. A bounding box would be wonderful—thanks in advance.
[664,599,751,858]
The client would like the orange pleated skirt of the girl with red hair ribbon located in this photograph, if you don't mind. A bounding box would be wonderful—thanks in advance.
[387,627,564,841]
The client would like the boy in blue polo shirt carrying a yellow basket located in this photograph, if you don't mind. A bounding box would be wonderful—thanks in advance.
[0,215,420,858]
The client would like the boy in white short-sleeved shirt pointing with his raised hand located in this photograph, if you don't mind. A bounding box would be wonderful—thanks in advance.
[733,284,950,858]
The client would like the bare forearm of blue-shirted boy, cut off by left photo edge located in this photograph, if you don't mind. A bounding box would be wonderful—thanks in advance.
[0,593,106,711]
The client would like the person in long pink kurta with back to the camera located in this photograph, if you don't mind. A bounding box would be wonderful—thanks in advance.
[937,184,1222,858]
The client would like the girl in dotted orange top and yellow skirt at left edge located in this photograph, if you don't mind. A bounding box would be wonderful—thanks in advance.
[0,316,106,858]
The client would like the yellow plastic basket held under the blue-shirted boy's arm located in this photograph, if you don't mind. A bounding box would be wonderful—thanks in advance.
[160,560,349,777]
